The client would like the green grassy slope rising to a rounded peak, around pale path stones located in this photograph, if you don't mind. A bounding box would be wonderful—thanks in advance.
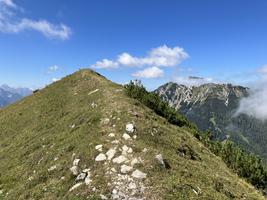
[0,70,264,200]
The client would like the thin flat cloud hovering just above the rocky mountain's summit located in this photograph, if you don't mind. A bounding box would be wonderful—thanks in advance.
[174,76,214,86]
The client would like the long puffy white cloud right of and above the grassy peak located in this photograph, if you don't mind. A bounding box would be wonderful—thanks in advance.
[91,45,189,69]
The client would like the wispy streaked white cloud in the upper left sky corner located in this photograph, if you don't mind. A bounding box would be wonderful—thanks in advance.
[0,0,71,40]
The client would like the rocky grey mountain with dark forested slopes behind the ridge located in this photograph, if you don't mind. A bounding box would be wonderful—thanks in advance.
[155,82,267,160]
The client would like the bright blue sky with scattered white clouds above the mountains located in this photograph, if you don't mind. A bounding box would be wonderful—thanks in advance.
[0,0,267,89]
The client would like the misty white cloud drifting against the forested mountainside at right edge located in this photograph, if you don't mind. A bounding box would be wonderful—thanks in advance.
[236,65,267,120]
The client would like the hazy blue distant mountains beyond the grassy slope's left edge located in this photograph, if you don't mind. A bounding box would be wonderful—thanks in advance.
[0,85,32,108]
